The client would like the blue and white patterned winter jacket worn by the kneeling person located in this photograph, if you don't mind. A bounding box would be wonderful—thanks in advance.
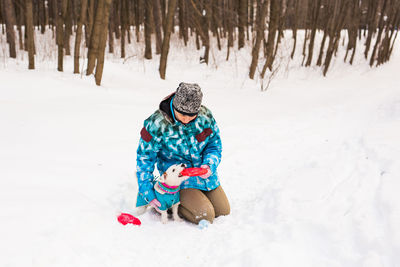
[136,94,222,207]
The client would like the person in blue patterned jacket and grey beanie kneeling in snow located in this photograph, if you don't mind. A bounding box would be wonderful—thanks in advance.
[136,83,230,223]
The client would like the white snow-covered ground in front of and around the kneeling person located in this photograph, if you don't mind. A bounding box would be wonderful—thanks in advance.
[0,34,400,267]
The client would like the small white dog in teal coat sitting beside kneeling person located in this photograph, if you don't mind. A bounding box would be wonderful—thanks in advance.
[139,164,189,224]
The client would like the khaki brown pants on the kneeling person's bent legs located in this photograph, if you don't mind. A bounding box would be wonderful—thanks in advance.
[179,186,230,224]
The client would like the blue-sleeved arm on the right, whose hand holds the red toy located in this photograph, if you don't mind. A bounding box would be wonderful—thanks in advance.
[202,118,222,173]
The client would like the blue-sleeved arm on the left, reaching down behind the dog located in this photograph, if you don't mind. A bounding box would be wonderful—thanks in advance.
[136,123,160,203]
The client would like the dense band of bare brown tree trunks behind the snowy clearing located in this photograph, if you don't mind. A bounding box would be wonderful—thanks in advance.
[0,0,400,85]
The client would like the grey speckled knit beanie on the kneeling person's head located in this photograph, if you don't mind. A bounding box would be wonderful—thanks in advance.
[172,83,203,116]
